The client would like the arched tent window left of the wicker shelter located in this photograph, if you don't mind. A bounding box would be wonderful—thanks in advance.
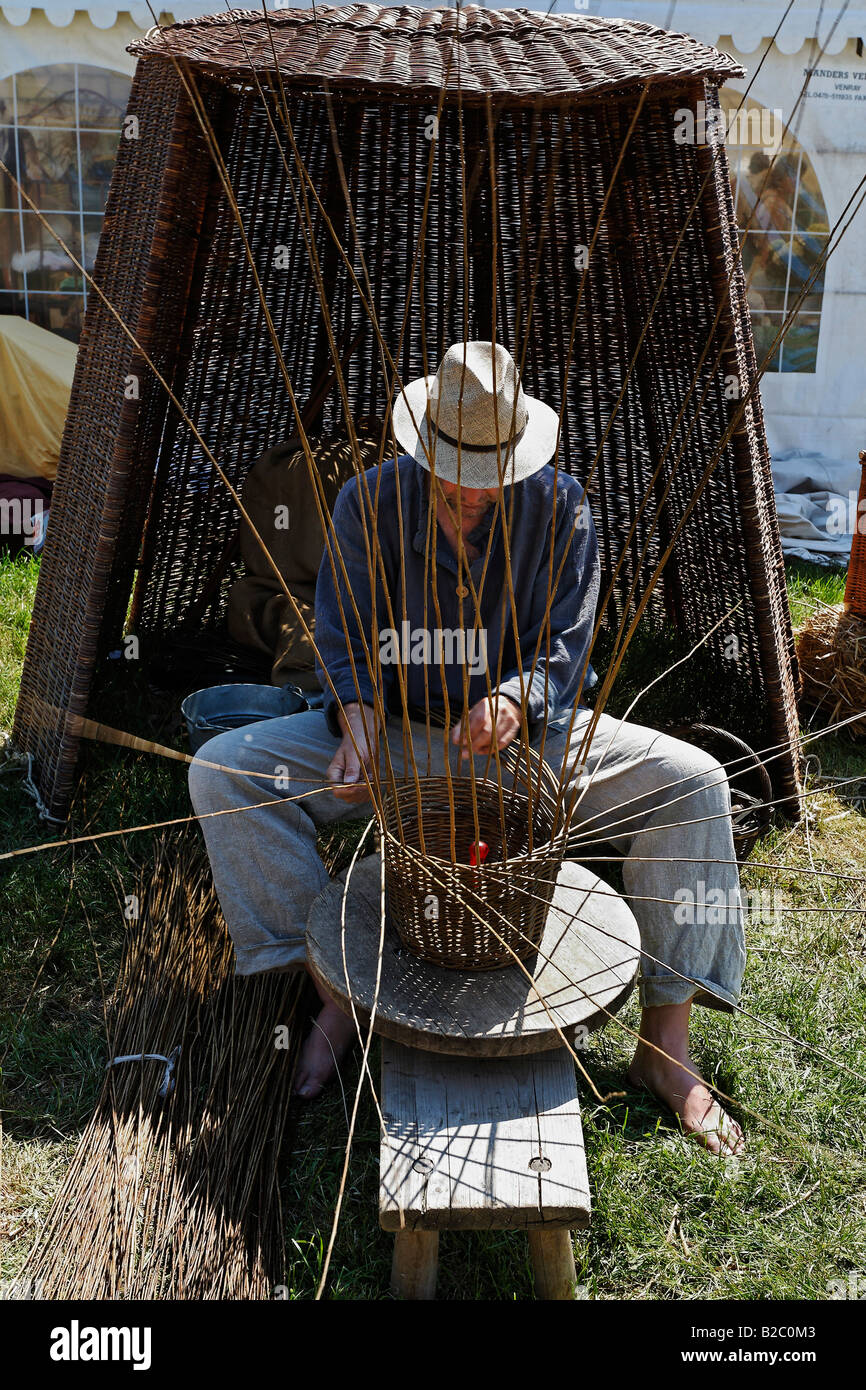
[0,63,131,342]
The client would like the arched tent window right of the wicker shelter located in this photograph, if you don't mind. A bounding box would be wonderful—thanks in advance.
[721,89,830,373]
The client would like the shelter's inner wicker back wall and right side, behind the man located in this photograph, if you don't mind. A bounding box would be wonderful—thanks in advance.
[132,89,794,794]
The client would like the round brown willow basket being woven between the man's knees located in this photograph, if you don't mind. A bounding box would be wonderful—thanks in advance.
[382,755,564,970]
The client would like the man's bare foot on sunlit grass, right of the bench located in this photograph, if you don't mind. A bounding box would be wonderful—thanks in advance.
[628,1005,745,1158]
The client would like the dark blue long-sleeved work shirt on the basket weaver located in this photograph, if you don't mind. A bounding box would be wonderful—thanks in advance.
[316,455,599,735]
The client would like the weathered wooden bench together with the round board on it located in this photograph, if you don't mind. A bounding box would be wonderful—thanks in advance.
[307,855,639,1298]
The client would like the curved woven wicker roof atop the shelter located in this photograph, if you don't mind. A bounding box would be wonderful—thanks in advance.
[128,4,744,101]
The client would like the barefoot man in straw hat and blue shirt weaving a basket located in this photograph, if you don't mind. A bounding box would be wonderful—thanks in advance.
[190,342,745,1155]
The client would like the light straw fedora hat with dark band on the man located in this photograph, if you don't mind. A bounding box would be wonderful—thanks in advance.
[393,342,559,488]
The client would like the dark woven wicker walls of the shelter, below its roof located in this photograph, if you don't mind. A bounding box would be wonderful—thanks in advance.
[15,7,798,815]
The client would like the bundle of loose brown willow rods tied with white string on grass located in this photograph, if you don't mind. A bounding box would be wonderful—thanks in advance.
[28,831,307,1298]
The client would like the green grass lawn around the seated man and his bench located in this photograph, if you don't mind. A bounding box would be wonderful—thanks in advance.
[0,547,866,1300]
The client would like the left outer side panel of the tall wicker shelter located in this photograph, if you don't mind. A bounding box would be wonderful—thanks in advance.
[13,61,224,820]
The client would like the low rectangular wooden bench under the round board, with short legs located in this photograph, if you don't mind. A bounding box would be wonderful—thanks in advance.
[379,1040,589,1300]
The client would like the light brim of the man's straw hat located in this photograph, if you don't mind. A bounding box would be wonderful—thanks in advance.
[393,375,559,488]
